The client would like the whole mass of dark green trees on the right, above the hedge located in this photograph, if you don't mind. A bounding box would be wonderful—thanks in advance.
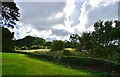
[73,20,120,62]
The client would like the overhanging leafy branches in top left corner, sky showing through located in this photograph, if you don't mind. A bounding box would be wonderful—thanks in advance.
[1,0,20,28]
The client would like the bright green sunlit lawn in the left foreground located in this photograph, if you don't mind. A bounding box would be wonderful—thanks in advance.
[2,53,97,75]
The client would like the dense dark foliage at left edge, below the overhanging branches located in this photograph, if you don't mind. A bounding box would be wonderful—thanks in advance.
[0,27,14,52]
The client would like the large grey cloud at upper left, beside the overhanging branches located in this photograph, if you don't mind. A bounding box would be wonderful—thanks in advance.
[17,2,65,30]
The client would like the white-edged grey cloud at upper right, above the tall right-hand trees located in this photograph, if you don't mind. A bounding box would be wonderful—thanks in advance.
[78,0,118,30]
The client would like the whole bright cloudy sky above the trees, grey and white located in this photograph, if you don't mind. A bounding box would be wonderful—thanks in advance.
[13,0,119,41]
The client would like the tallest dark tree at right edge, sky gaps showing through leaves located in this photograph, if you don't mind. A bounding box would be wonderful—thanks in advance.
[92,20,120,57]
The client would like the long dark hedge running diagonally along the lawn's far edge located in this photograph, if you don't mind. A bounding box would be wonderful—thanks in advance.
[27,53,120,73]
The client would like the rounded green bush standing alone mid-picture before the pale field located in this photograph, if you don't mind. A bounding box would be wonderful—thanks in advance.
[51,40,65,51]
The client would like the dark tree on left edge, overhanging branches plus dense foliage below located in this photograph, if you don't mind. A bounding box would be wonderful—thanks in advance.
[0,0,20,51]
